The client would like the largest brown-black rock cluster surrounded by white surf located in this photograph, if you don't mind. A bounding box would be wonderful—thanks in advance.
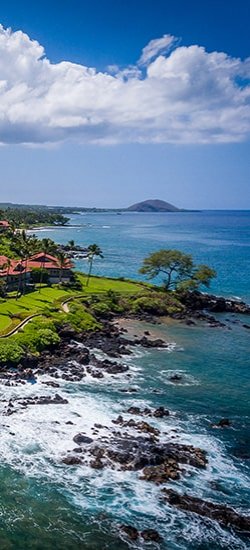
[63,432,207,484]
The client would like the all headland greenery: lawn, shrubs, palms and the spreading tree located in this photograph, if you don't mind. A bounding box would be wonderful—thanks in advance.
[0,229,215,363]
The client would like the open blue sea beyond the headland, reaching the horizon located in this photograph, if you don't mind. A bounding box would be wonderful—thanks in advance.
[34,211,250,300]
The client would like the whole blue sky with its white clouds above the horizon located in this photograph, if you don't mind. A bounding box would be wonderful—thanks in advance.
[0,0,250,209]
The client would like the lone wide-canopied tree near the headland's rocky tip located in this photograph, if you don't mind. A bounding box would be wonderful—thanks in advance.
[139,249,216,290]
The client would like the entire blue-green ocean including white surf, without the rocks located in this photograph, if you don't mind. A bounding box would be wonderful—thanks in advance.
[0,211,250,550]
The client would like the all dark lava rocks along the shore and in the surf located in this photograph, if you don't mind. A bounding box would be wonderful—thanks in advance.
[0,294,250,542]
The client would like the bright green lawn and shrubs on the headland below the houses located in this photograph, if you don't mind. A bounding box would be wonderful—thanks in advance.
[0,280,183,363]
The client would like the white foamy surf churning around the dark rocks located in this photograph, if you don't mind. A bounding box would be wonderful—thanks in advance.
[0,350,247,550]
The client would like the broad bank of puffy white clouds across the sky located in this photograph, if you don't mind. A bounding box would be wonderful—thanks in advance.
[0,26,250,145]
